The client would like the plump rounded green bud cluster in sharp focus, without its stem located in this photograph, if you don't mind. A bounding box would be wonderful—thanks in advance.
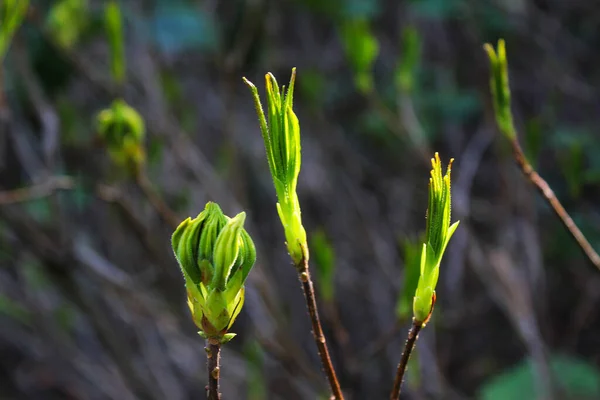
[171,202,256,343]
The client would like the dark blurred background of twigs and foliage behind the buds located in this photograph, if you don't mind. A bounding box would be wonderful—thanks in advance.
[0,0,600,400]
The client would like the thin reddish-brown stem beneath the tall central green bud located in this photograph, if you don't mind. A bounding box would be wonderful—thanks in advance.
[297,259,344,400]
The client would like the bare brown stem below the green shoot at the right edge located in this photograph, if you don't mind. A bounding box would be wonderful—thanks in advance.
[512,137,600,269]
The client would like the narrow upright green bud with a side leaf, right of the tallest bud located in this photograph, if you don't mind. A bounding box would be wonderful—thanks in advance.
[413,153,459,324]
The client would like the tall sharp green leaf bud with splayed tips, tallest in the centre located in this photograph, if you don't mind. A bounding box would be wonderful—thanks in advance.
[244,68,308,265]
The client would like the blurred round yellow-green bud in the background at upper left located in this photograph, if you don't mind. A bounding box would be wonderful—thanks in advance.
[97,100,146,174]
